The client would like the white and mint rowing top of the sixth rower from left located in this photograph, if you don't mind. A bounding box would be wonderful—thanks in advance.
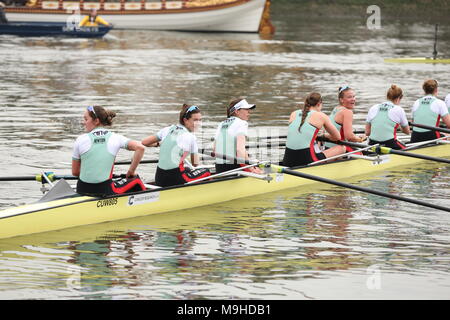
[366,101,408,142]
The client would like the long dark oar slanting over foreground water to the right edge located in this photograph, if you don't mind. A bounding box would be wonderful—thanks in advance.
[271,165,450,212]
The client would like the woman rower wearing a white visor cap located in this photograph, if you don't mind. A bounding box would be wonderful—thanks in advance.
[213,97,262,174]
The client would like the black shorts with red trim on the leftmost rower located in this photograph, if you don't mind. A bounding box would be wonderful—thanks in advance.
[77,177,145,197]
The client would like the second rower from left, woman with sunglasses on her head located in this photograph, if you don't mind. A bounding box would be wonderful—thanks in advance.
[142,104,211,187]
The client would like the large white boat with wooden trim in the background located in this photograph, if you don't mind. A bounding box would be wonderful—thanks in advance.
[4,0,273,32]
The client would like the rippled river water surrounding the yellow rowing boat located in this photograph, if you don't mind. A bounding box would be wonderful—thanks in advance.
[0,2,450,299]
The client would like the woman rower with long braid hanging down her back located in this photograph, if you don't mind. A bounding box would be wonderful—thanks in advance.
[283,92,346,167]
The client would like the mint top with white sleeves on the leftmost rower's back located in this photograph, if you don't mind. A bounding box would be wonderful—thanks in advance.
[72,128,130,183]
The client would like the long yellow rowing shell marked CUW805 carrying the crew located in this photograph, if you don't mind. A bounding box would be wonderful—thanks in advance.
[0,144,450,238]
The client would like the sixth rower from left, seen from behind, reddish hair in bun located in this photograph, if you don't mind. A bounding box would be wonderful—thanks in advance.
[366,84,411,150]
